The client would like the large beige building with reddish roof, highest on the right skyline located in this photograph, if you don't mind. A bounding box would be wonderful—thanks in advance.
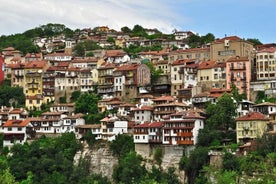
[210,36,253,62]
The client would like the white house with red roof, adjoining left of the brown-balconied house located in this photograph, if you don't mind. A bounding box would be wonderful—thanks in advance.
[133,122,163,144]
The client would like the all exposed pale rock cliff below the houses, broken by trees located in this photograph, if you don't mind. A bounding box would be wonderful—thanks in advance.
[74,143,188,181]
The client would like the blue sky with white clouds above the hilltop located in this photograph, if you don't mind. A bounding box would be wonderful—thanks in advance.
[0,0,276,43]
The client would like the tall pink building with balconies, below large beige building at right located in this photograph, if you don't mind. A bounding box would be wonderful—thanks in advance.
[226,56,251,99]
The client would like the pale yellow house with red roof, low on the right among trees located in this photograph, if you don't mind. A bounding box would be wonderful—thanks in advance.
[236,112,269,143]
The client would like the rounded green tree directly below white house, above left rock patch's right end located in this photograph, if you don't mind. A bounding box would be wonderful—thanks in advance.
[110,134,134,157]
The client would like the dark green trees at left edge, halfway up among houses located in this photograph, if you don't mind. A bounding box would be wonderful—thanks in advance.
[0,85,25,107]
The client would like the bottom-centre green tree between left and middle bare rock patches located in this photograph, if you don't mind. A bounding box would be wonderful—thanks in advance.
[112,151,147,184]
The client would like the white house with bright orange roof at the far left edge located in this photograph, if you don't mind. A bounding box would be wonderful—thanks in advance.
[2,120,31,147]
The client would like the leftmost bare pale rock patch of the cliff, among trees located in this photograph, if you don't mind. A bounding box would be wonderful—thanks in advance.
[74,144,118,180]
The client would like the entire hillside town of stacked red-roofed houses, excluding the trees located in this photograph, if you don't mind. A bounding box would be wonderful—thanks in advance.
[0,26,276,157]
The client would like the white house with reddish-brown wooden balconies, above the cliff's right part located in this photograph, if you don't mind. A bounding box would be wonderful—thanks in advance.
[162,110,205,146]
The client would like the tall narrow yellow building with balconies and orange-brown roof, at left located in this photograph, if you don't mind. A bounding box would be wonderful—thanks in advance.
[24,61,48,109]
